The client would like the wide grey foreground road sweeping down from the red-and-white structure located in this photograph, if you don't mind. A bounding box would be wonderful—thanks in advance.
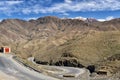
[0,53,58,80]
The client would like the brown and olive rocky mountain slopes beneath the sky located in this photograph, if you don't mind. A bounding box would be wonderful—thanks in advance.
[0,16,120,79]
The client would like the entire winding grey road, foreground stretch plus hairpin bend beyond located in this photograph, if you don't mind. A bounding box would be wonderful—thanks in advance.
[0,53,86,80]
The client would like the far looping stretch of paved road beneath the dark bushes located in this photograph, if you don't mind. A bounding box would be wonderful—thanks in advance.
[28,57,86,77]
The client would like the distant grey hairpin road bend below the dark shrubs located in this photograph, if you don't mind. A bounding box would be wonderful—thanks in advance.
[28,57,89,80]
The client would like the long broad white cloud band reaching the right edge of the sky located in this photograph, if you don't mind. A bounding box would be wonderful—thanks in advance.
[26,0,120,13]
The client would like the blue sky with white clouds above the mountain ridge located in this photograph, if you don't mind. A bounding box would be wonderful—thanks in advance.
[0,0,120,21]
